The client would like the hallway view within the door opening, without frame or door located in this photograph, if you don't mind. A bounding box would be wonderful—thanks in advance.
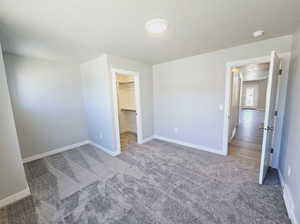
[229,63,270,169]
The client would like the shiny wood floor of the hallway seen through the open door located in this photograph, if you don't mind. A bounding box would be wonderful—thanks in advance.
[229,109,265,169]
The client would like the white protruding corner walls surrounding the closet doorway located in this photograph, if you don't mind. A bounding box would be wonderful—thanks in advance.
[81,54,153,152]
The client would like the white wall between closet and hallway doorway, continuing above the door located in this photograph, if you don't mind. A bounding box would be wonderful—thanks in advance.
[153,36,292,152]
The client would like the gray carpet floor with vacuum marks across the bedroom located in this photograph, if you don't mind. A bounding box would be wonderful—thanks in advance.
[0,140,290,224]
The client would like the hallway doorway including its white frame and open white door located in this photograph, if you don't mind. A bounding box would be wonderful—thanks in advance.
[223,51,286,184]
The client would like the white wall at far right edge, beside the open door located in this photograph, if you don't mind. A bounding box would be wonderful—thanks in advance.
[280,26,300,223]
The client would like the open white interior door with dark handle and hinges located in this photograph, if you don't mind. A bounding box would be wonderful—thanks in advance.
[259,51,280,184]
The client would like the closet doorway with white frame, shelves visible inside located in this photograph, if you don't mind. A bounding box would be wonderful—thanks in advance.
[112,69,143,153]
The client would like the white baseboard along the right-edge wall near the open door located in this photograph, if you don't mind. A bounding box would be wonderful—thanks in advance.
[278,169,299,224]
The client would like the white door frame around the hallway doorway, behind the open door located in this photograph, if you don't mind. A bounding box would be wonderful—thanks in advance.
[222,51,291,164]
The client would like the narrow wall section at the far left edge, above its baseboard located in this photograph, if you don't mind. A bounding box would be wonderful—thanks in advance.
[0,45,27,200]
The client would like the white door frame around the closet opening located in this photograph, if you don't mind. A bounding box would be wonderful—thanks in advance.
[111,68,143,154]
